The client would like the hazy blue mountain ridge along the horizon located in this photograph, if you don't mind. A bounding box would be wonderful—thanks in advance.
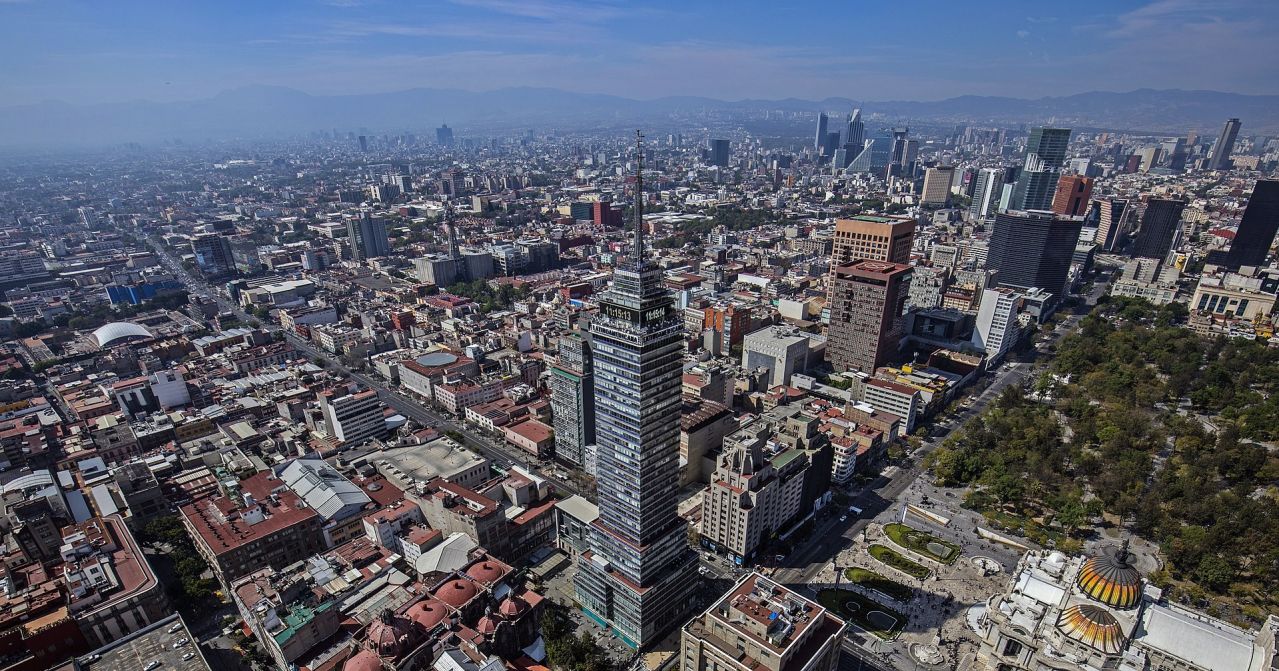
[0,86,1279,147]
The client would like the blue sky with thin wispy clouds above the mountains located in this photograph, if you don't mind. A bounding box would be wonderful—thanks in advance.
[0,0,1279,106]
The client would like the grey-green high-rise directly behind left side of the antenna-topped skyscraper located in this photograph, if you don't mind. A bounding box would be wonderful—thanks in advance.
[551,334,595,467]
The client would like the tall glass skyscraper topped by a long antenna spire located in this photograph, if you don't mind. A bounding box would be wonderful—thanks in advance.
[574,133,697,648]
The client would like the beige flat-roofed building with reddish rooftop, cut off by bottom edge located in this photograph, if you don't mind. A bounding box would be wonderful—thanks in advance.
[679,573,848,671]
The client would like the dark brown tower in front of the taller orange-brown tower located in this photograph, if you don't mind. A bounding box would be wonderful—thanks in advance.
[826,259,912,373]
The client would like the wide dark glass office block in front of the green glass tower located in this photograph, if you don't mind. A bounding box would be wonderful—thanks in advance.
[986,210,1083,297]
